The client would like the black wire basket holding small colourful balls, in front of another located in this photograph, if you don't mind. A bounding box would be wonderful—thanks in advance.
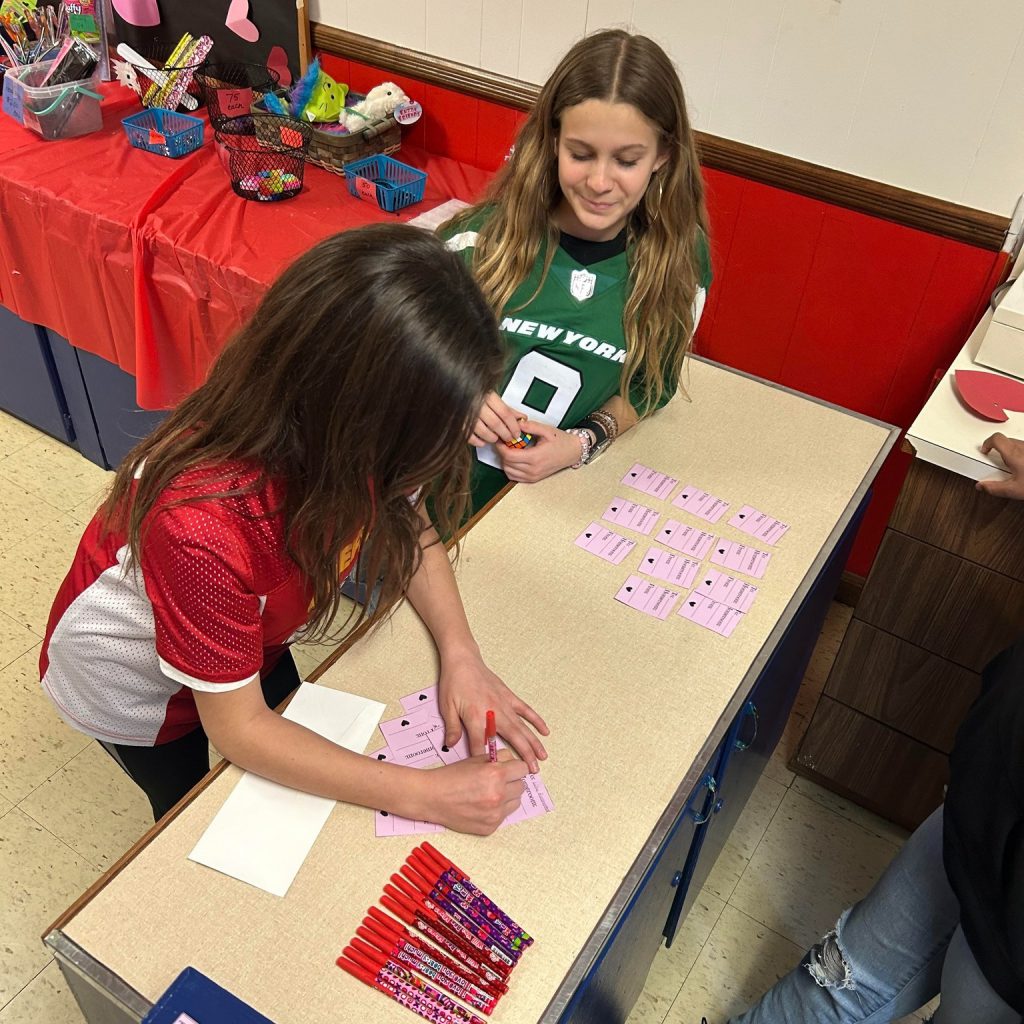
[214,114,312,203]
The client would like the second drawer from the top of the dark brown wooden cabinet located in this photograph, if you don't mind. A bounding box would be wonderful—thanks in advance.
[857,529,1024,672]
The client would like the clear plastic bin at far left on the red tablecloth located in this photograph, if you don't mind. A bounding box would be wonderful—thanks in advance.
[3,60,103,139]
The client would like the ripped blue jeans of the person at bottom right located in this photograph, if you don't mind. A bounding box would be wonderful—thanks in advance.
[730,807,1021,1024]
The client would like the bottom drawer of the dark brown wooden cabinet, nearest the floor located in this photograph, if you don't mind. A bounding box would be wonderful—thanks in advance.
[793,696,949,829]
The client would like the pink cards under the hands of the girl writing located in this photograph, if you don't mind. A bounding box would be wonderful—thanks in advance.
[367,686,555,836]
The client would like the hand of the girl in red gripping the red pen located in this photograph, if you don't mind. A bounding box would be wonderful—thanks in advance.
[417,751,526,836]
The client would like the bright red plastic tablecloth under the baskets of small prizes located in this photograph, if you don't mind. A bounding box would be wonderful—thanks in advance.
[0,85,489,409]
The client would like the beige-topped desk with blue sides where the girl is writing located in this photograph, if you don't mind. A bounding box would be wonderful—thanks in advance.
[41,359,896,1024]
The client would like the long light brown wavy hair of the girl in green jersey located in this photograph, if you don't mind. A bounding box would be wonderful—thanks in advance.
[453,29,708,413]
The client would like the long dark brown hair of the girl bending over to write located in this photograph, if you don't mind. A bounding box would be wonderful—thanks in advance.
[101,224,503,637]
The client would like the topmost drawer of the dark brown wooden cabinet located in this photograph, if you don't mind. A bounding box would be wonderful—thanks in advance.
[890,459,1024,581]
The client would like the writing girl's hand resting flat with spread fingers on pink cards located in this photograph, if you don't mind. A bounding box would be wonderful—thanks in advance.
[437,654,548,770]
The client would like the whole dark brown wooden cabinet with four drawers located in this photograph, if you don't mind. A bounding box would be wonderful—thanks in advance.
[791,460,1024,828]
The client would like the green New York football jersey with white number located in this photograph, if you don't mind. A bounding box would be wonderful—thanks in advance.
[445,214,707,511]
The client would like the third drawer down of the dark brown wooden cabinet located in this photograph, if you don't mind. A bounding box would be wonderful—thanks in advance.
[824,618,981,754]
